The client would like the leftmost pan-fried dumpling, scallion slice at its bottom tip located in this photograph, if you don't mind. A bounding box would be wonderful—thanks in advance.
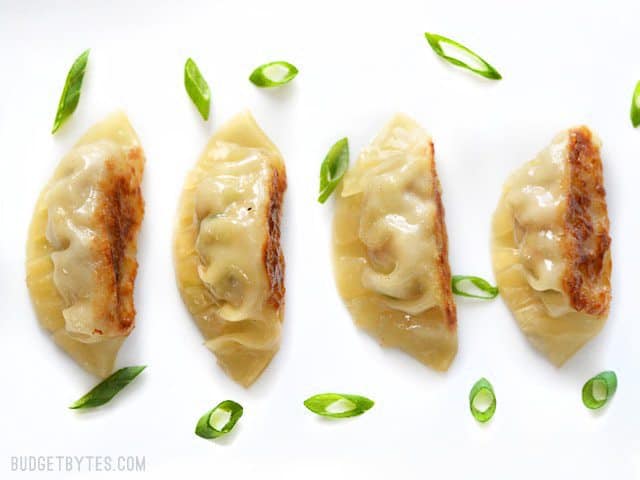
[26,112,144,377]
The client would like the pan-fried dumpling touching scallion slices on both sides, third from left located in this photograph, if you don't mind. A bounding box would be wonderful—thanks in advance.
[333,115,458,370]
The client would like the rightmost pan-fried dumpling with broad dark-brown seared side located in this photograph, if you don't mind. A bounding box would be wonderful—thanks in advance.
[493,127,611,366]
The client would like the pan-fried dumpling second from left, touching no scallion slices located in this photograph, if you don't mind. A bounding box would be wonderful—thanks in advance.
[174,112,287,386]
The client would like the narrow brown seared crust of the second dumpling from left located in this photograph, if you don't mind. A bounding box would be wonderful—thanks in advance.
[263,163,287,310]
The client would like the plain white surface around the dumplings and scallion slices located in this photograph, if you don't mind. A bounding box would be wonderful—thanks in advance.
[0,0,640,479]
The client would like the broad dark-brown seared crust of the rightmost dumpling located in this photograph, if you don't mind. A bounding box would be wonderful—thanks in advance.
[563,127,611,316]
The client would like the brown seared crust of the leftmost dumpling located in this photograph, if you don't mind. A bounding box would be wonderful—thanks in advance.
[94,147,144,335]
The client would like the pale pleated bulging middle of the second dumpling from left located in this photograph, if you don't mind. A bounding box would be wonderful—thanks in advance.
[195,150,272,321]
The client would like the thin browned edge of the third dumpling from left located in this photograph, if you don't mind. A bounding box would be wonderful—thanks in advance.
[430,142,457,330]
